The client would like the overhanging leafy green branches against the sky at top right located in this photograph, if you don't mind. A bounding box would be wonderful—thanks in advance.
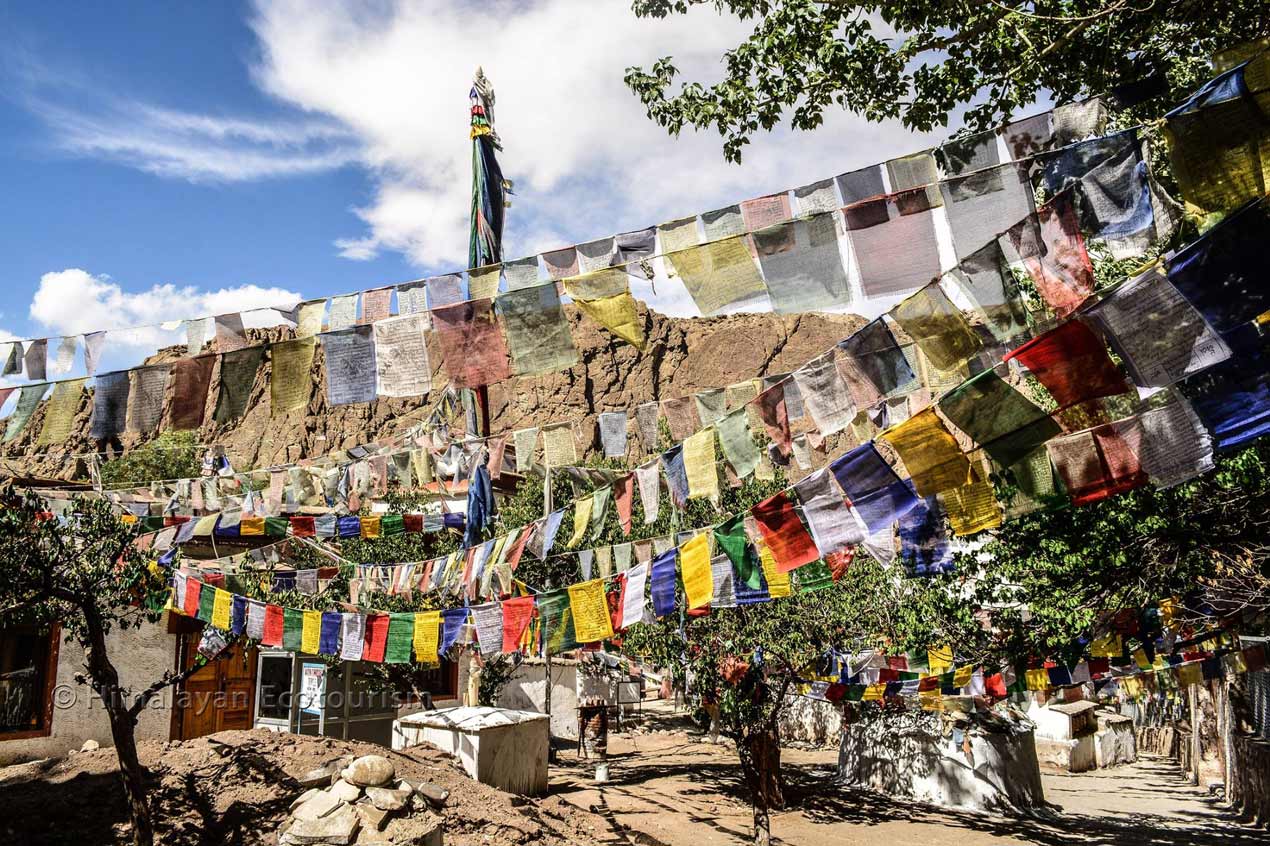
[625,0,1270,161]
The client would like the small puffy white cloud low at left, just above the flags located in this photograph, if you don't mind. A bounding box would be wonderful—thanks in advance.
[30,268,301,365]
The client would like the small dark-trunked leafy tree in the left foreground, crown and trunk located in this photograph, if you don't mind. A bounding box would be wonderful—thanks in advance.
[0,493,206,846]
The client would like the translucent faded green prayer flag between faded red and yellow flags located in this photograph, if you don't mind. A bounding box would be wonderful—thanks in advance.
[498,282,578,376]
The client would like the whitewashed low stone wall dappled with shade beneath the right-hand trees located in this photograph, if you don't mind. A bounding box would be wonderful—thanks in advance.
[838,714,1045,812]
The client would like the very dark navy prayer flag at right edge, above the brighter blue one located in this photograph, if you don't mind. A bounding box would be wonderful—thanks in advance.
[1168,198,1270,335]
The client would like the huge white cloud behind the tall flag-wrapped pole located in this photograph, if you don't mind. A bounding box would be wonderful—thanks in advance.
[251,0,935,269]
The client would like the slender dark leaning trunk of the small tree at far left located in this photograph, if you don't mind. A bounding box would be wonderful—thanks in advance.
[83,603,155,846]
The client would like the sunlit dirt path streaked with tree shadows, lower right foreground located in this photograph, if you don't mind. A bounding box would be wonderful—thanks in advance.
[551,732,1270,846]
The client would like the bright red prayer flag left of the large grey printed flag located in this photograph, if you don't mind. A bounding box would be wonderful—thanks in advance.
[1006,319,1129,408]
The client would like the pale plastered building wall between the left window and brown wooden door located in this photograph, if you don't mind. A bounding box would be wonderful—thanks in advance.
[0,615,177,766]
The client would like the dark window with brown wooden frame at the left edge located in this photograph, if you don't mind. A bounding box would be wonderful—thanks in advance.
[0,626,58,741]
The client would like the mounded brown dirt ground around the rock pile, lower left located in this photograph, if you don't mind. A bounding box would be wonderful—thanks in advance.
[0,729,612,846]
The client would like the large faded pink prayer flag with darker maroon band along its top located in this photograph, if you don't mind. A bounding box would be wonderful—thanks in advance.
[839,186,940,297]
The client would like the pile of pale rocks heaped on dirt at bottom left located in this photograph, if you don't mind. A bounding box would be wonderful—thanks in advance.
[278,755,450,846]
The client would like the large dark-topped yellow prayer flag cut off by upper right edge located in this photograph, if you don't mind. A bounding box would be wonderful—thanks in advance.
[1165,51,1270,212]
